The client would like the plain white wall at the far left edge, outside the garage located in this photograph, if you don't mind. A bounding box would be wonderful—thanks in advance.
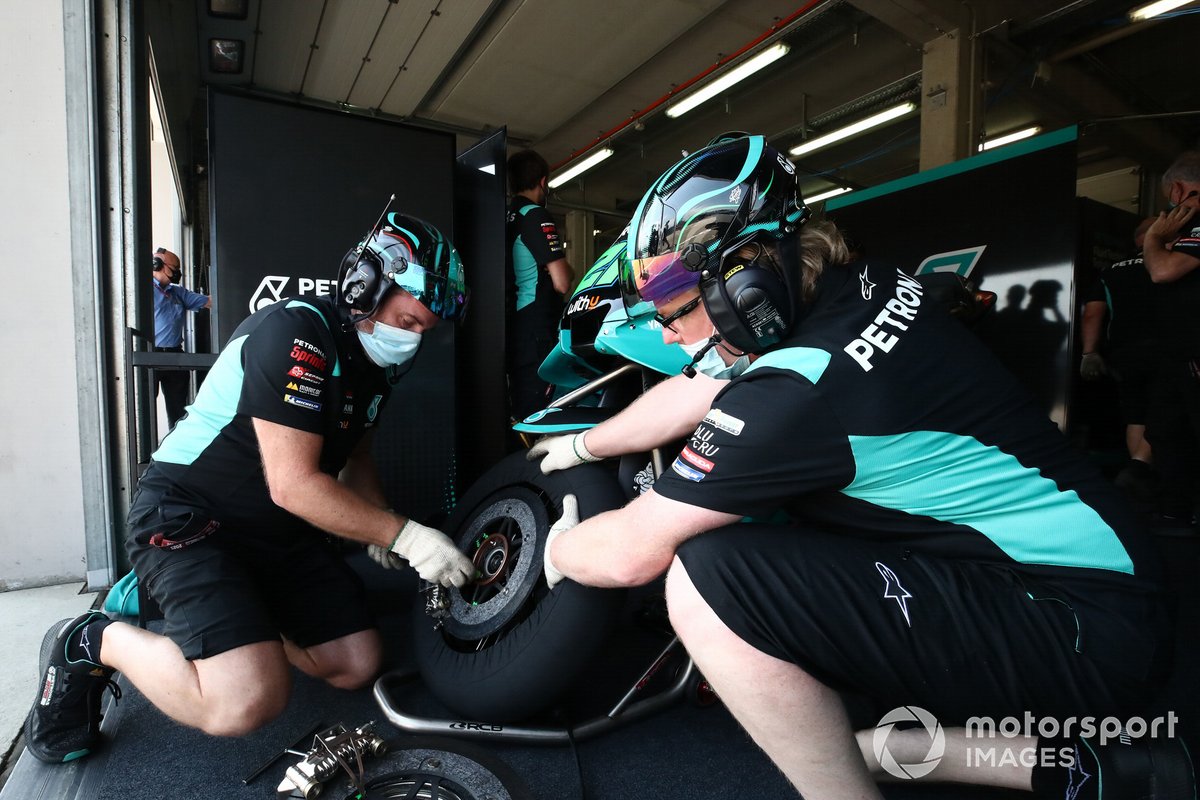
[0,0,90,590]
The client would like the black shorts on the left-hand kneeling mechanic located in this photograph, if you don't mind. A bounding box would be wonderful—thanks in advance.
[126,486,376,660]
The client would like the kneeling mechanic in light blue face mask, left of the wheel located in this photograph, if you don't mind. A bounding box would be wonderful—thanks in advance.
[25,213,474,762]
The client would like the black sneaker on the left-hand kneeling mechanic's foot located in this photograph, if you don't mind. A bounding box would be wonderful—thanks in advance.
[25,612,121,764]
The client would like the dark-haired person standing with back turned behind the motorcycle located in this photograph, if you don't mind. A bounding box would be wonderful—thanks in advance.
[505,150,574,420]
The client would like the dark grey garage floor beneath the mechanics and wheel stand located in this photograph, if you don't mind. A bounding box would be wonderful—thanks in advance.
[0,536,1200,800]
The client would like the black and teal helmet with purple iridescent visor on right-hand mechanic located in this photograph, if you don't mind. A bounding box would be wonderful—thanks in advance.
[623,133,809,307]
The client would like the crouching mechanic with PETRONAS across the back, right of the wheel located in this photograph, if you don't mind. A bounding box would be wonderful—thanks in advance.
[528,137,1194,800]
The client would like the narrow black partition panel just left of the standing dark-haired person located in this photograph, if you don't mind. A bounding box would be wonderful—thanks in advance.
[455,128,509,486]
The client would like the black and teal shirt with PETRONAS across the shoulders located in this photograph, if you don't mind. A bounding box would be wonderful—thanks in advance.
[655,263,1153,581]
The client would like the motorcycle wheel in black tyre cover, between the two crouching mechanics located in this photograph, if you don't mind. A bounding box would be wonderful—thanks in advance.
[413,452,625,723]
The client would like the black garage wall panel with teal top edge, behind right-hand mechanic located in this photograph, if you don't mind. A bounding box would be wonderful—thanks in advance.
[826,127,1078,431]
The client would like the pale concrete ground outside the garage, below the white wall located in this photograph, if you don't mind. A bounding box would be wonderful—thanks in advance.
[0,583,96,774]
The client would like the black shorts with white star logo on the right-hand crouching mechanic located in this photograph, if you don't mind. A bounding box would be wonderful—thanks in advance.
[678,524,1170,724]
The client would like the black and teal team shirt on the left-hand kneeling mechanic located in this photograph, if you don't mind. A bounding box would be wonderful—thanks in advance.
[143,297,390,525]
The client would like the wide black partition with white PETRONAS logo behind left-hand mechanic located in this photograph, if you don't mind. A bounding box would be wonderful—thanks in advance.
[209,92,457,519]
